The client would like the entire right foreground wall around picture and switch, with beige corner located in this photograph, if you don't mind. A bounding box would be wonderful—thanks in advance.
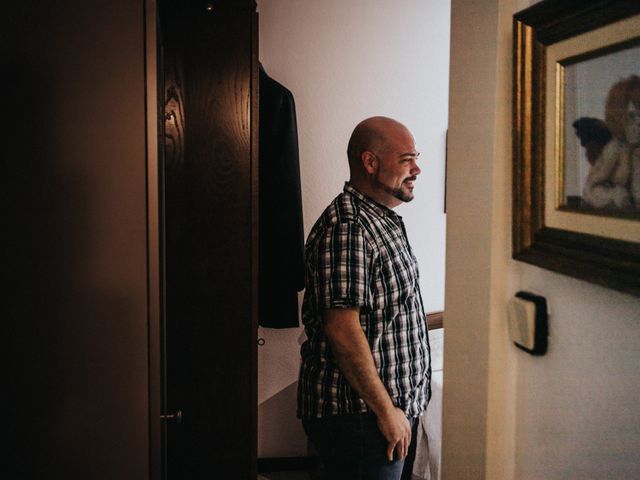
[442,0,640,480]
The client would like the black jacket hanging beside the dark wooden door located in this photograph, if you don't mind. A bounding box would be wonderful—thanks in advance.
[258,65,304,328]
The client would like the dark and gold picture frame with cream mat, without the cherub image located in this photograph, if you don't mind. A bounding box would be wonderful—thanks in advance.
[513,0,640,296]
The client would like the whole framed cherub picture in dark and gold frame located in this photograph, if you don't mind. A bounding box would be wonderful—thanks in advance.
[513,0,640,296]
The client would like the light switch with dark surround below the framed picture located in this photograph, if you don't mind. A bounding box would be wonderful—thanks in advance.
[508,292,549,355]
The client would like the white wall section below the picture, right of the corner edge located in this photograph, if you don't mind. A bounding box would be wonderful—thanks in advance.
[509,266,640,479]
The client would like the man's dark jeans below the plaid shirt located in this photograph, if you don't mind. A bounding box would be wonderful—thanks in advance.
[302,413,411,480]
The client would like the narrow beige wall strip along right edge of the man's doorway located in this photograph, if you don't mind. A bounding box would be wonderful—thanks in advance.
[442,0,499,479]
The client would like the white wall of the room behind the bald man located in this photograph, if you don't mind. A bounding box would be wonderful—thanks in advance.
[258,0,450,457]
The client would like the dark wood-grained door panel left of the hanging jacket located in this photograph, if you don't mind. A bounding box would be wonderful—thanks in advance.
[160,0,258,480]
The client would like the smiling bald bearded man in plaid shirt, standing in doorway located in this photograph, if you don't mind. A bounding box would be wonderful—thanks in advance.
[298,117,431,480]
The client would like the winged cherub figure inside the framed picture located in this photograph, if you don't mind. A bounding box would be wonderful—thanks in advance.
[573,75,640,209]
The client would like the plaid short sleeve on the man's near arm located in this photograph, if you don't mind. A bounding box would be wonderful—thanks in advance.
[317,222,371,310]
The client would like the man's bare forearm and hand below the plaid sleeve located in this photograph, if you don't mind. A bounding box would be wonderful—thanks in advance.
[324,308,411,461]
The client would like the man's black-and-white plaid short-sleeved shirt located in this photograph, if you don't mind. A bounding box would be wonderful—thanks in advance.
[298,183,431,417]
